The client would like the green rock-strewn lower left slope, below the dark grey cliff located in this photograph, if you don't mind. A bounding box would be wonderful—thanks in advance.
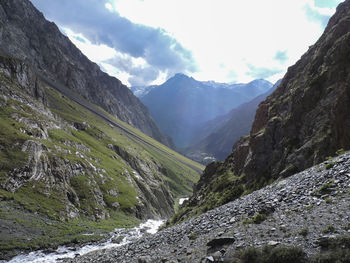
[0,51,201,258]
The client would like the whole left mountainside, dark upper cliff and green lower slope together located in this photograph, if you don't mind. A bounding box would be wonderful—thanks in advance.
[0,0,203,259]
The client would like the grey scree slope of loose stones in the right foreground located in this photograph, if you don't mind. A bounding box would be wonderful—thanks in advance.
[64,153,350,263]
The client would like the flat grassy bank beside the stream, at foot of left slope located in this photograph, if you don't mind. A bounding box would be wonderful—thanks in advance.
[0,205,139,255]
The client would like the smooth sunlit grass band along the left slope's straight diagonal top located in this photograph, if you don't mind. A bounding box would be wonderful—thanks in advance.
[44,86,204,197]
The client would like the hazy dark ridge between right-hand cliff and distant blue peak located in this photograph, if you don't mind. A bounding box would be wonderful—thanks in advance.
[182,82,280,164]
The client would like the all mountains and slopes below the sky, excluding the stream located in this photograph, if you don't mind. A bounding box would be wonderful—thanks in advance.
[0,0,350,263]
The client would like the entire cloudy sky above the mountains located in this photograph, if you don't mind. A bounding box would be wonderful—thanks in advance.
[31,0,342,86]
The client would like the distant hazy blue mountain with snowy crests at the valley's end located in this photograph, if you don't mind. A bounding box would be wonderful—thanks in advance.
[140,74,272,147]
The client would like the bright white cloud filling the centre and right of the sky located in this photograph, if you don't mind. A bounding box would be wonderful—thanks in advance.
[109,0,342,82]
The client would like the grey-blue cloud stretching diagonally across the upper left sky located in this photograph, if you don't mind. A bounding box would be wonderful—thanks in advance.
[31,0,197,85]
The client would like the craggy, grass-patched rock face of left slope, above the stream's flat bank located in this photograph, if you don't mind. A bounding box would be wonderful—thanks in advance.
[0,56,174,223]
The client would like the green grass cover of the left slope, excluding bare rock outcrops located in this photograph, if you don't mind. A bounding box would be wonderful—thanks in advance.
[0,67,203,258]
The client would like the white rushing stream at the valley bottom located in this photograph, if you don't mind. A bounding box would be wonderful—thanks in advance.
[8,220,164,263]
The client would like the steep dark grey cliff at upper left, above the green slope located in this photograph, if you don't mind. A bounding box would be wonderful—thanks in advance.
[0,0,171,146]
